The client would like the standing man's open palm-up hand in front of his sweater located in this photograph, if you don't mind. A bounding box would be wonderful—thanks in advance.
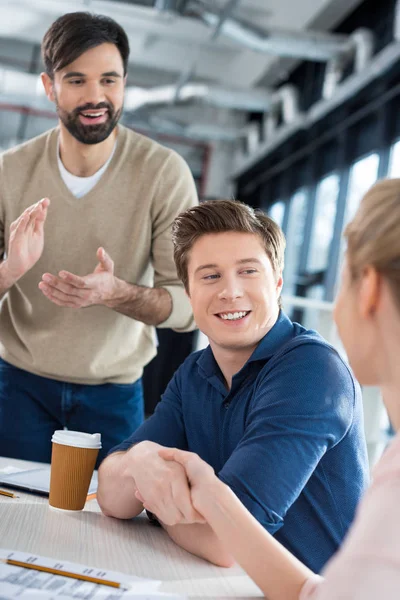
[39,248,116,308]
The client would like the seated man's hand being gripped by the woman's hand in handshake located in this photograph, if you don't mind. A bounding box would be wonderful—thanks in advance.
[130,441,204,526]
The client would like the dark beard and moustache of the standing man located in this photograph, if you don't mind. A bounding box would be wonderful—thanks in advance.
[55,99,122,144]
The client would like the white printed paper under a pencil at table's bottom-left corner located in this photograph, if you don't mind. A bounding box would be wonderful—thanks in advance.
[0,548,182,600]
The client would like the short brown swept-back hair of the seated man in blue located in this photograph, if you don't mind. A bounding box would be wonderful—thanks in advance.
[172,200,286,300]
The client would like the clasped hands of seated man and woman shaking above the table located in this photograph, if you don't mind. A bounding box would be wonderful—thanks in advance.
[97,441,223,526]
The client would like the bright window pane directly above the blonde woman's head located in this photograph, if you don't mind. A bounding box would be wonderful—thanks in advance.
[344,154,379,225]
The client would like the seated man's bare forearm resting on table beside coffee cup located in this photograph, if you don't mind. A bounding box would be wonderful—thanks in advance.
[97,452,143,519]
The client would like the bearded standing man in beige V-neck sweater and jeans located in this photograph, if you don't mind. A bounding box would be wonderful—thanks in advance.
[0,12,197,462]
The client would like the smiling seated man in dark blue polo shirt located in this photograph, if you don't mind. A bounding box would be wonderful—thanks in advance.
[98,200,368,572]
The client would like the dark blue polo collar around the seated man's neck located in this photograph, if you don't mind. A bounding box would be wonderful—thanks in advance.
[197,311,294,379]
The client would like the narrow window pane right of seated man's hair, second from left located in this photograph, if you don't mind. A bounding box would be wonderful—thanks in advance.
[283,188,308,296]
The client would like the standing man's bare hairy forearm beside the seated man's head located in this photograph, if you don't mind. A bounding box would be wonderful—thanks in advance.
[105,278,172,326]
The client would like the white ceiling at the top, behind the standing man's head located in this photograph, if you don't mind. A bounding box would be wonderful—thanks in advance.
[0,0,366,88]
